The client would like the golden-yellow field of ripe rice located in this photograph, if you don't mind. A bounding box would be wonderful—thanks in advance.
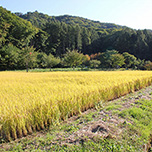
[0,71,152,141]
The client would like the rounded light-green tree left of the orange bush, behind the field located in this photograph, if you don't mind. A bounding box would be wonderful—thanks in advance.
[63,50,84,68]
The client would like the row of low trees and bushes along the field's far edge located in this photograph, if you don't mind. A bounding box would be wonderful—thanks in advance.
[0,44,152,72]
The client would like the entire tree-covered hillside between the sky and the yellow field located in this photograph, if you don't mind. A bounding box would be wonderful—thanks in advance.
[0,7,152,70]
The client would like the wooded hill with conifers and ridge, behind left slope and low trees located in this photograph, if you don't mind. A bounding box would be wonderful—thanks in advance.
[15,11,152,60]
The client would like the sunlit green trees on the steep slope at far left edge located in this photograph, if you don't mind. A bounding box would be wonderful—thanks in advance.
[0,7,38,48]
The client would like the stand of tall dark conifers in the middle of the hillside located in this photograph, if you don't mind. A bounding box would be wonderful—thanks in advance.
[43,21,99,56]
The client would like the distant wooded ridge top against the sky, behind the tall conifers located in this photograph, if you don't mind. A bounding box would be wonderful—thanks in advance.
[15,11,124,30]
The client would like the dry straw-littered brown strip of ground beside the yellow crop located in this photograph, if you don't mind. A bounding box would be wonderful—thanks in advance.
[57,87,152,144]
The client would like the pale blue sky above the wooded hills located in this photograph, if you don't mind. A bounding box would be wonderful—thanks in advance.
[0,0,152,29]
